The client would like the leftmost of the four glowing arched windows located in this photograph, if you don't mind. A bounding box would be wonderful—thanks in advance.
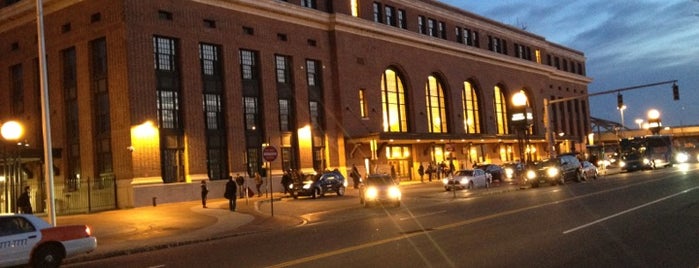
[381,69,408,132]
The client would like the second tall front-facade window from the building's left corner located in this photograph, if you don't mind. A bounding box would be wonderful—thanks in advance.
[199,44,228,180]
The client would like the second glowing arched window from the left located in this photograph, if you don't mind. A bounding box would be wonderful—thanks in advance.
[425,75,448,133]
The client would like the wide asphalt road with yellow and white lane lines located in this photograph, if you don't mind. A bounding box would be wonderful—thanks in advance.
[68,166,699,267]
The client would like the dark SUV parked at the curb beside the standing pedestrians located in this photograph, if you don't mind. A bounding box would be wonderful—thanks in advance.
[288,171,347,199]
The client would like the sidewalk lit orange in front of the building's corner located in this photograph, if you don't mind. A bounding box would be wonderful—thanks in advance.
[56,193,302,264]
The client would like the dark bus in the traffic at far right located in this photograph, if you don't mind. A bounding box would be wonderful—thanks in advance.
[619,135,674,171]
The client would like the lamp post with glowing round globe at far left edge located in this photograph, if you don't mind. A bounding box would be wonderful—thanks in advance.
[0,121,24,212]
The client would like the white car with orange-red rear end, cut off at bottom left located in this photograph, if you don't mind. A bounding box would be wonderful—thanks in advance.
[0,214,97,267]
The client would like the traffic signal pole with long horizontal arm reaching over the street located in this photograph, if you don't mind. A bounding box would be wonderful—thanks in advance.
[544,80,680,157]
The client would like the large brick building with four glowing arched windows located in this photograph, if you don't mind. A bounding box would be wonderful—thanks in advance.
[0,0,591,213]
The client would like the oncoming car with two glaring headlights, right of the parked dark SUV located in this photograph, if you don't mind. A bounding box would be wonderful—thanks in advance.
[359,174,401,207]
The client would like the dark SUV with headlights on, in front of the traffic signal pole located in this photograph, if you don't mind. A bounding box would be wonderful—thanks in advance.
[524,154,583,187]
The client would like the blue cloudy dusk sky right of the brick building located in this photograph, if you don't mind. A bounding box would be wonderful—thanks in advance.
[441,0,699,128]
